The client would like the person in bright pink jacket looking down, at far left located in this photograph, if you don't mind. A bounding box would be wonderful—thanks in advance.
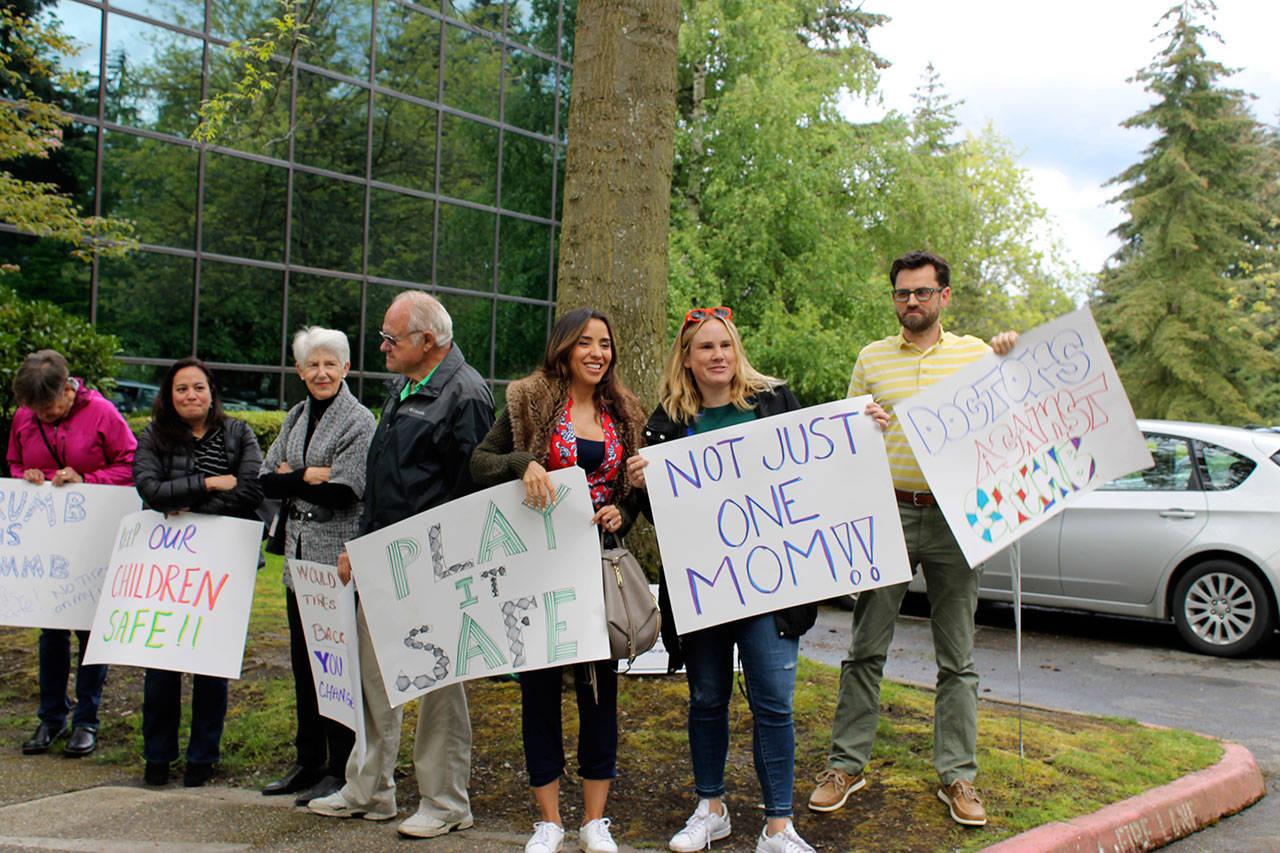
[6,350,138,758]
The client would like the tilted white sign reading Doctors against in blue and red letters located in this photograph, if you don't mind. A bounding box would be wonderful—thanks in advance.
[896,309,1151,566]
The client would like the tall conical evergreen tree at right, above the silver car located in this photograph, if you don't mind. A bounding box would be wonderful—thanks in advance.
[1097,0,1274,423]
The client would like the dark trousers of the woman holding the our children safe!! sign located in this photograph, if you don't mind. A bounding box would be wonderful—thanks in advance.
[142,670,227,765]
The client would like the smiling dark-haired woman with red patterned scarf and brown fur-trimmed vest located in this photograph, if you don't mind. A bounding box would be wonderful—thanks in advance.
[471,307,644,853]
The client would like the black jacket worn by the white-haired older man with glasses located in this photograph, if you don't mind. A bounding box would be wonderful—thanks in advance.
[360,343,493,535]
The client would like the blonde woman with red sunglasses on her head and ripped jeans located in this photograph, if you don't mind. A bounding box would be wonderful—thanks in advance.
[627,306,818,853]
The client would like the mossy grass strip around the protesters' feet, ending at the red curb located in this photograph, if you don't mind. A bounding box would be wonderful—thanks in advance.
[0,556,1221,852]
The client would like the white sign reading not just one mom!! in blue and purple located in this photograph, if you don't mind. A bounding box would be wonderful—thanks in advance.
[640,397,911,634]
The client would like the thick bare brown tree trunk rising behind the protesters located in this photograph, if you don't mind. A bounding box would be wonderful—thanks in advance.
[557,0,681,405]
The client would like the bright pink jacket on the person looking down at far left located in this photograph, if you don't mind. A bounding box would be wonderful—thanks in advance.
[6,383,138,485]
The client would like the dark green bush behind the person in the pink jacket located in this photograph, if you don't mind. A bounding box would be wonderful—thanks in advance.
[0,286,120,420]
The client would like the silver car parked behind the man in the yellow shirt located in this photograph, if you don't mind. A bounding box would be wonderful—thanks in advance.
[911,420,1280,657]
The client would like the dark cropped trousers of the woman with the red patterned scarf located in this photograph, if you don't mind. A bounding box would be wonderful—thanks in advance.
[520,661,618,788]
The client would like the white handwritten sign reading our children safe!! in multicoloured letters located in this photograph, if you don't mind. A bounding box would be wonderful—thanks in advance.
[84,510,262,679]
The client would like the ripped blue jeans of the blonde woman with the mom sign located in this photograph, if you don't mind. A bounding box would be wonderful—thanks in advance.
[681,613,800,817]
